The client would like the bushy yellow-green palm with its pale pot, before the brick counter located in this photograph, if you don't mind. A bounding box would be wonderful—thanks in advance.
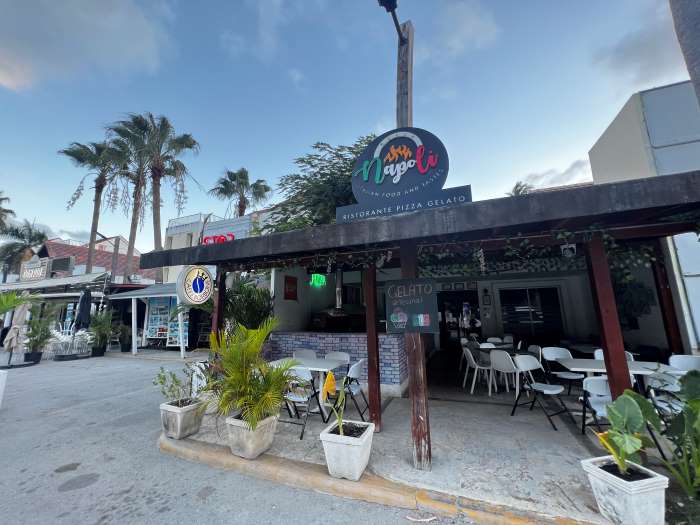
[207,318,294,459]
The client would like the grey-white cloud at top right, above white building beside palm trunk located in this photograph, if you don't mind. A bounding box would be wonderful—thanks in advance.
[593,2,688,91]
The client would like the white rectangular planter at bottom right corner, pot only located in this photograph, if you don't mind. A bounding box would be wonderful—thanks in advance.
[581,456,668,525]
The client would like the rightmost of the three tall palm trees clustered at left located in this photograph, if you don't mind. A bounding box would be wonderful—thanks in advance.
[143,113,199,250]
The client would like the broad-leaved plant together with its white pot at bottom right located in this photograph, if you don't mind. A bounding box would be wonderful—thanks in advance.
[581,390,668,525]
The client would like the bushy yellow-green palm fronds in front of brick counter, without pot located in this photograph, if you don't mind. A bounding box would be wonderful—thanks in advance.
[206,318,295,430]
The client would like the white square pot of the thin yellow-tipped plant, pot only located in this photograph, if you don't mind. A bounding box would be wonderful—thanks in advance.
[321,421,374,481]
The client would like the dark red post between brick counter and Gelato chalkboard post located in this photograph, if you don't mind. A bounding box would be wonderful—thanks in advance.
[362,264,382,432]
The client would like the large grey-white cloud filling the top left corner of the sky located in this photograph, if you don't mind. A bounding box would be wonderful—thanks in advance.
[0,0,172,90]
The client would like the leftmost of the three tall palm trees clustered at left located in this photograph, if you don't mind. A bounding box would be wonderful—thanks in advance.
[59,142,116,273]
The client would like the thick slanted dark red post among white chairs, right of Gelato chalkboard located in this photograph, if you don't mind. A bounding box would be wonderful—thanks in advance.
[586,237,632,399]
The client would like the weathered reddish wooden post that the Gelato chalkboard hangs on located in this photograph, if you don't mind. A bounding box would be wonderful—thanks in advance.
[401,242,432,470]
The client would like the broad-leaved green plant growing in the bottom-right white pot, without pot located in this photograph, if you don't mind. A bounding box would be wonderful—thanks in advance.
[596,390,658,474]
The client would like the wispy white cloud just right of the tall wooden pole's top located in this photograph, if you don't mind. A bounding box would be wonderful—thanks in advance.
[415,0,501,64]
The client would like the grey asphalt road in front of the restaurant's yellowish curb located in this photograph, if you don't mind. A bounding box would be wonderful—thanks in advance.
[0,357,476,525]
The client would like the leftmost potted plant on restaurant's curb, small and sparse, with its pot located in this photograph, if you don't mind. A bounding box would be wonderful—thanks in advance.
[153,365,206,439]
